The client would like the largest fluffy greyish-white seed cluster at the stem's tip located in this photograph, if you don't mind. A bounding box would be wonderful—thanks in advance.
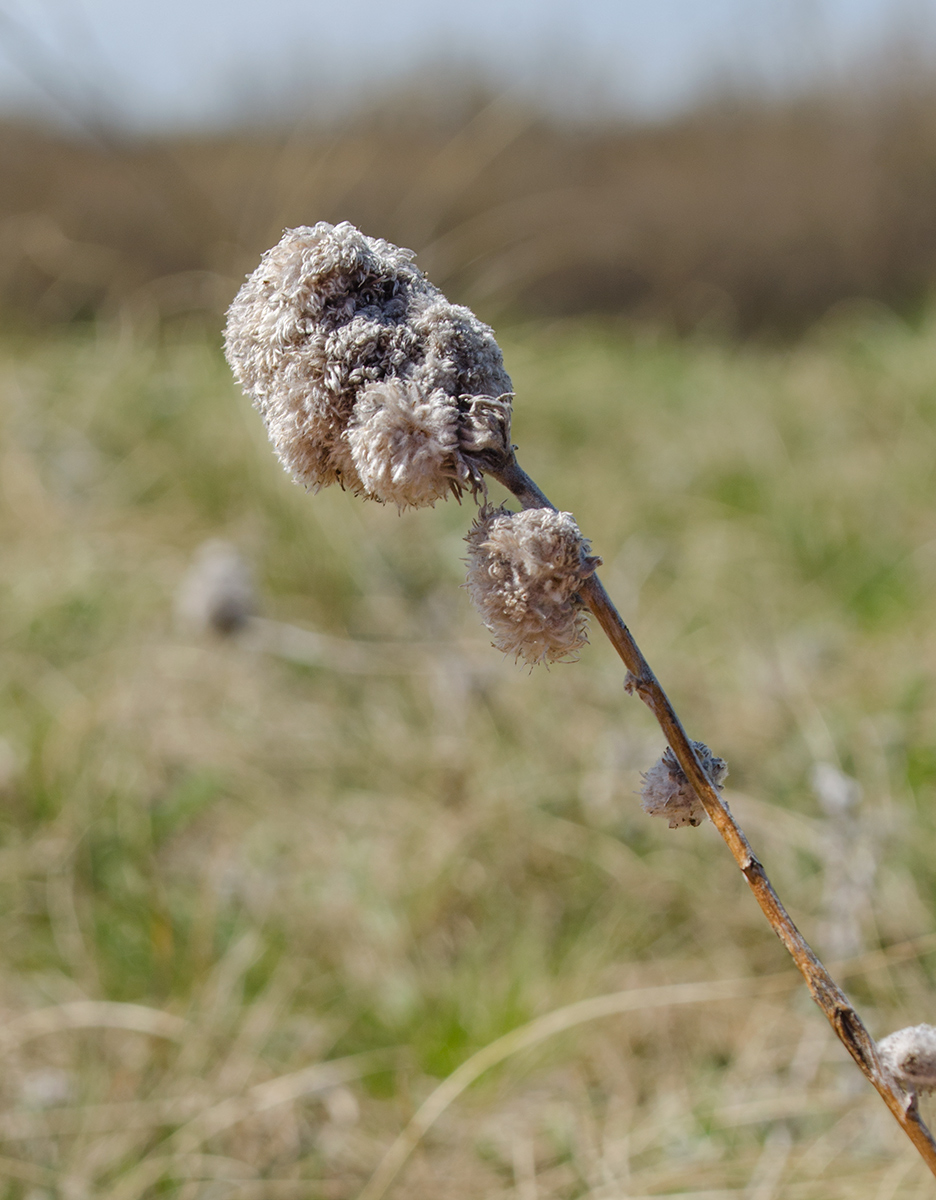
[224,221,511,509]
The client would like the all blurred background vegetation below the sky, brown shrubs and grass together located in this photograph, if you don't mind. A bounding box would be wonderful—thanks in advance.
[0,44,936,1200]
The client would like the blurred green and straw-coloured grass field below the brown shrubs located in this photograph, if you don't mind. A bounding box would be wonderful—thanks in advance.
[0,308,936,1200]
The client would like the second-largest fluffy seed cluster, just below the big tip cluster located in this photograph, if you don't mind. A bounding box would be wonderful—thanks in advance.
[466,508,601,664]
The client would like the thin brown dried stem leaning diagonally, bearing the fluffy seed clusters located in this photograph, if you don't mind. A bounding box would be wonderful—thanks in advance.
[488,460,936,1175]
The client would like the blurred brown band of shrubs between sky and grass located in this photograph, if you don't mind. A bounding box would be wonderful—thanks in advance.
[0,76,936,335]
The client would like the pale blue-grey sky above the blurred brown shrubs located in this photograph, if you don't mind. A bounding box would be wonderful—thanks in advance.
[0,0,936,127]
